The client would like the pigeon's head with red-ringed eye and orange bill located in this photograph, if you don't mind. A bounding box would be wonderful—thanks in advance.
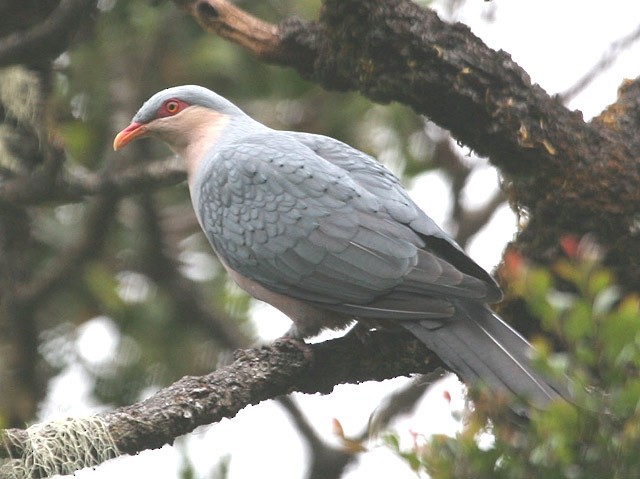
[113,85,244,156]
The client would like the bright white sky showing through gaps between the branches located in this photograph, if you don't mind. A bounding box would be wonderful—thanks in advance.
[43,0,640,479]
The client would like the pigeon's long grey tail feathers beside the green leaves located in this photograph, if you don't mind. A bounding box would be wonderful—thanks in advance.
[403,302,569,413]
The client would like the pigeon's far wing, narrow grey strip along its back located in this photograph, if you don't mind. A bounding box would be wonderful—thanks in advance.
[289,132,502,302]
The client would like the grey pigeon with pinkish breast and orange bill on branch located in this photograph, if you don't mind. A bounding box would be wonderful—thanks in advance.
[113,85,566,408]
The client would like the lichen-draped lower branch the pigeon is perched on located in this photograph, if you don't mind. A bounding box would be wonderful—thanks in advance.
[0,332,442,477]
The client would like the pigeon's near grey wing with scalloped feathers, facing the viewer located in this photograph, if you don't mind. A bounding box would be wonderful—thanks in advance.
[197,134,498,319]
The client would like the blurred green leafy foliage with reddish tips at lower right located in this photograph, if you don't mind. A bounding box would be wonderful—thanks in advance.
[386,238,640,479]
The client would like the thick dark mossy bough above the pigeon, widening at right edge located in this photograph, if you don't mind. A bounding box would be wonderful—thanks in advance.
[175,0,640,296]
